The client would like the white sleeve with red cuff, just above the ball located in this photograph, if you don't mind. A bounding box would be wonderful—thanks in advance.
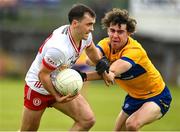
[42,48,65,70]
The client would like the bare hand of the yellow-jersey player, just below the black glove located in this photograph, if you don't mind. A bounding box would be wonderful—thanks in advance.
[102,71,115,86]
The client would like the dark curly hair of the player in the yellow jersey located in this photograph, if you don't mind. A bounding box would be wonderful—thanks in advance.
[101,8,137,33]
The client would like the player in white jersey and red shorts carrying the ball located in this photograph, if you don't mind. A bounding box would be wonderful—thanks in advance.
[20,4,107,131]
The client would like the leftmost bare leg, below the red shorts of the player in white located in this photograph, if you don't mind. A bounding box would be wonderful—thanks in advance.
[20,107,45,131]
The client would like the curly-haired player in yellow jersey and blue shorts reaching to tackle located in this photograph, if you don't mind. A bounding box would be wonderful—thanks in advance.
[76,8,172,131]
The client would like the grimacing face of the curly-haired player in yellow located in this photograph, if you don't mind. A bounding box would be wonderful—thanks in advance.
[108,24,129,50]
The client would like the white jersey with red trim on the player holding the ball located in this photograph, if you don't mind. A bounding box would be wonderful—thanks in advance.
[25,25,92,95]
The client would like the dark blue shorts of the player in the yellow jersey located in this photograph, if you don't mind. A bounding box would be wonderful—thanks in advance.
[122,86,172,115]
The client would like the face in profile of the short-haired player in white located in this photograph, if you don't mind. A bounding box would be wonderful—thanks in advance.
[76,13,95,40]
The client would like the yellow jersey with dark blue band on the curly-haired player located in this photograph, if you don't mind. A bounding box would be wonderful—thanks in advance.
[97,37,165,99]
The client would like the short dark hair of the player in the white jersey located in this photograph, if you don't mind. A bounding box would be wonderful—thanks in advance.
[68,4,96,24]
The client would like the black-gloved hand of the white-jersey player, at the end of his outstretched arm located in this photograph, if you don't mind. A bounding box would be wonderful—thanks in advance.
[96,56,109,75]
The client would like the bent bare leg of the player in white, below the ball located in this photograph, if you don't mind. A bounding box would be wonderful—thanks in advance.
[52,94,95,131]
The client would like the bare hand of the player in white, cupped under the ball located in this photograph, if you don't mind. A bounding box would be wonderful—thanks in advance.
[55,93,79,103]
